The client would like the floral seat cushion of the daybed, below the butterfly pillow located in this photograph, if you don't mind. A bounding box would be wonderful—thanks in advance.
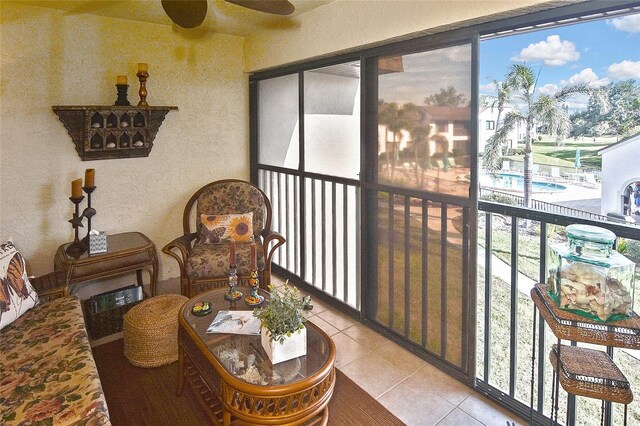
[0,297,111,426]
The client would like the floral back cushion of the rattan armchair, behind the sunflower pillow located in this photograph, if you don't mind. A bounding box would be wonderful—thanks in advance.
[196,182,265,238]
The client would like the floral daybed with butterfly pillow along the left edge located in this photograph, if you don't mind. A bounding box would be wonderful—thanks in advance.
[0,240,111,426]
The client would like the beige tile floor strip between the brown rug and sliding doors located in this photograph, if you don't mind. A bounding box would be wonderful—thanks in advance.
[276,282,526,426]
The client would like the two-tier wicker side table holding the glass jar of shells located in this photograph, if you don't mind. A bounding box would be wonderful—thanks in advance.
[531,284,640,425]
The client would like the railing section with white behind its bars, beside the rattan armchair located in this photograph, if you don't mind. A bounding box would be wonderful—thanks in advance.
[258,166,361,310]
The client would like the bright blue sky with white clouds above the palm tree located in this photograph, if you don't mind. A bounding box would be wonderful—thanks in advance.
[480,14,640,109]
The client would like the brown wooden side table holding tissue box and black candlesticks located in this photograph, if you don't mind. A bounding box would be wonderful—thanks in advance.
[54,232,158,296]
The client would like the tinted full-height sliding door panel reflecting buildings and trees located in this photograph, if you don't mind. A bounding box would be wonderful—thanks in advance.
[364,42,476,382]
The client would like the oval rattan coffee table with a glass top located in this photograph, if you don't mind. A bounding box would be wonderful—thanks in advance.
[178,288,336,425]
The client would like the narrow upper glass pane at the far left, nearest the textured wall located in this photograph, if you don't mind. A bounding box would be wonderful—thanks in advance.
[258,74,300,169]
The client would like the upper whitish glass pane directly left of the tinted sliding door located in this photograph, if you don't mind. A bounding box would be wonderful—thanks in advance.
[304,62,360,179]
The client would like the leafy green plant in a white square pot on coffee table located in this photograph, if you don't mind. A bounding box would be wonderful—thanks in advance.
[253,284,311,364]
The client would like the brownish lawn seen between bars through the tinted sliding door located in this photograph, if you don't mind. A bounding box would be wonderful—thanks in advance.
[374,199,463,365]
